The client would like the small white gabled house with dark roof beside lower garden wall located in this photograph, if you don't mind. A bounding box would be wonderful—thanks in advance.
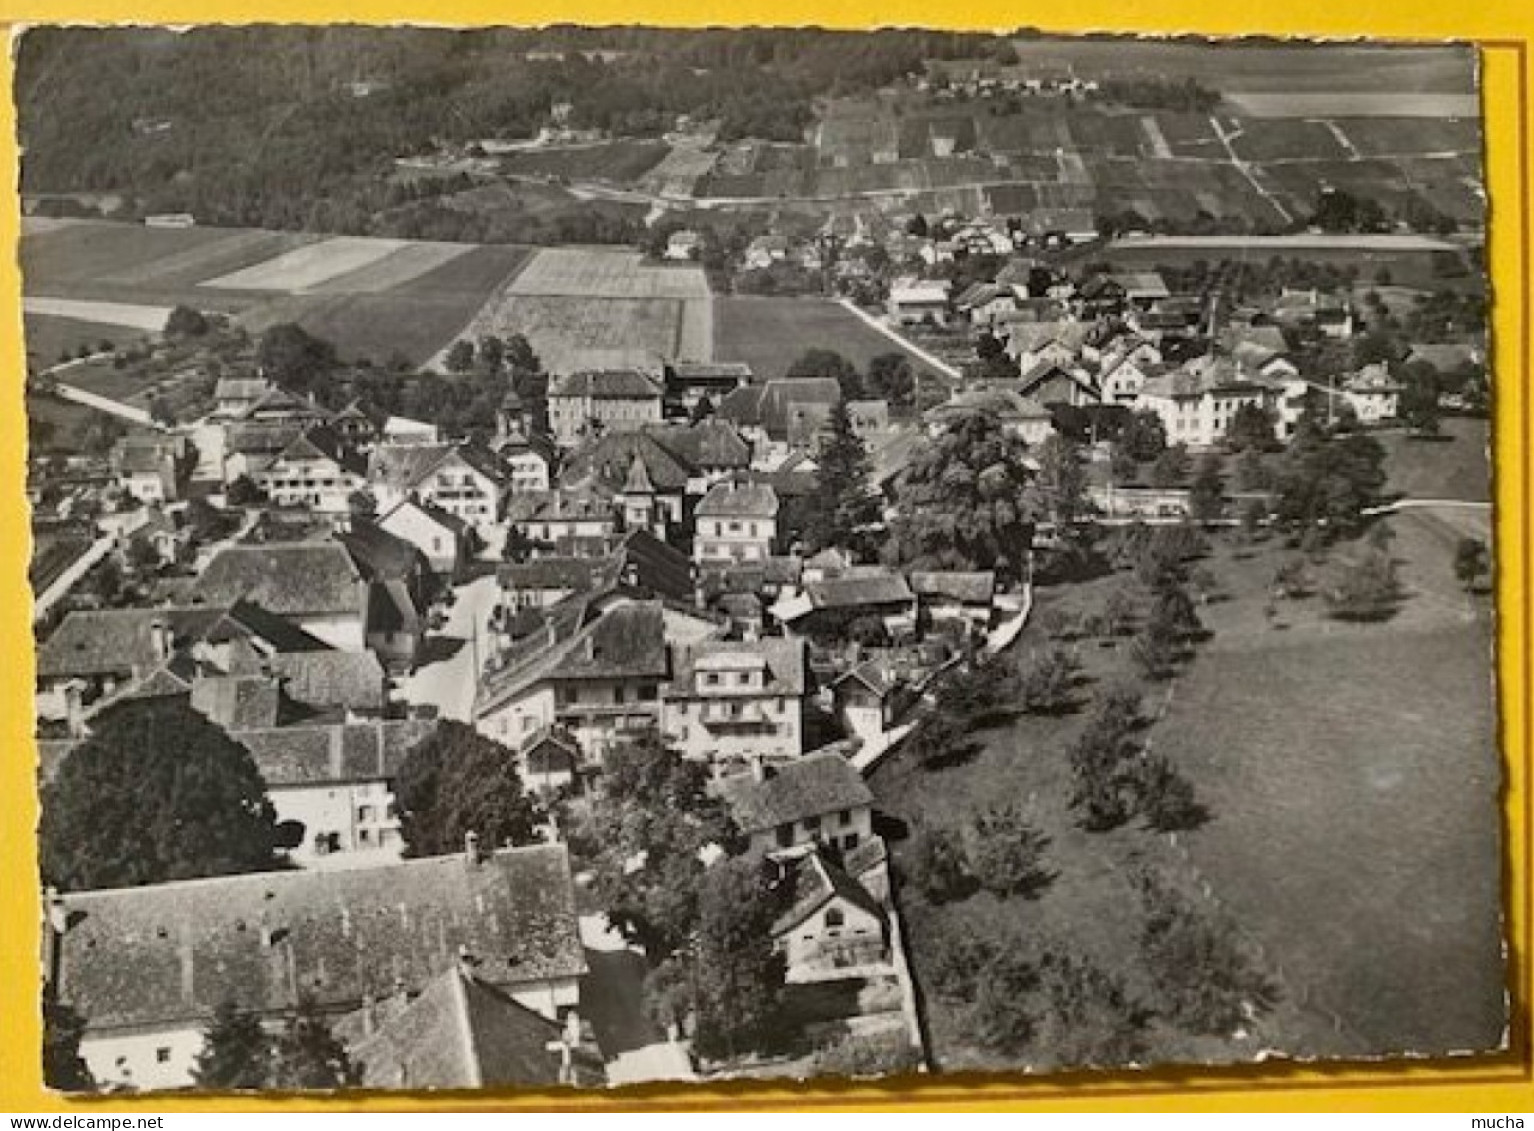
[772,850,890,984]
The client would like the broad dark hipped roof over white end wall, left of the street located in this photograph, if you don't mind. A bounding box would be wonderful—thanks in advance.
[196,542,362,615]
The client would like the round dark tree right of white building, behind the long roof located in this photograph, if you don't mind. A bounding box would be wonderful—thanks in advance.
[394,720,543,856]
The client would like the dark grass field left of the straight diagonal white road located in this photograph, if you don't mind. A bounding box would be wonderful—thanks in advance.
[713,295,939,381]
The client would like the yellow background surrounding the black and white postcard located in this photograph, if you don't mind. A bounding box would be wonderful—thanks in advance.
[0,0,1534,1114]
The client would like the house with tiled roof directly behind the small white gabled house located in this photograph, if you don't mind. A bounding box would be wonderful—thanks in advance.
[715,752,873,855]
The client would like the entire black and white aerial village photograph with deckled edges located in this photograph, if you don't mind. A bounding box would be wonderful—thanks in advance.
[12,25,1509,1093]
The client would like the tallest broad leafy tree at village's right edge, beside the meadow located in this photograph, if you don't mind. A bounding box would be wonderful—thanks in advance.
[884,413,1034,580]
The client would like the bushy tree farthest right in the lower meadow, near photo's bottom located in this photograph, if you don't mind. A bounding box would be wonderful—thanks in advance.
[1138,873,1278,1036]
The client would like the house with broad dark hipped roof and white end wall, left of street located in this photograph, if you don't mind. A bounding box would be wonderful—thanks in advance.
[195,542,367,652]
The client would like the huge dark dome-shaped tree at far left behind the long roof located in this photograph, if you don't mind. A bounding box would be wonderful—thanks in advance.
[38,698,278,890]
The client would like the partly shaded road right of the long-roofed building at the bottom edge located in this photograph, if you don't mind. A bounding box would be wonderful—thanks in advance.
[580,915,693,1083]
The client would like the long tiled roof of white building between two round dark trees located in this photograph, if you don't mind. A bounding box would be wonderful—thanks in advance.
[232,718,437,789]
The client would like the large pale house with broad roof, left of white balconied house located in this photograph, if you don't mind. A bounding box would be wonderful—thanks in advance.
[474,595,670,757]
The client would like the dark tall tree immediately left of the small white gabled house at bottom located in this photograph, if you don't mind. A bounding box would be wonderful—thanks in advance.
[693,856,787,1059]
